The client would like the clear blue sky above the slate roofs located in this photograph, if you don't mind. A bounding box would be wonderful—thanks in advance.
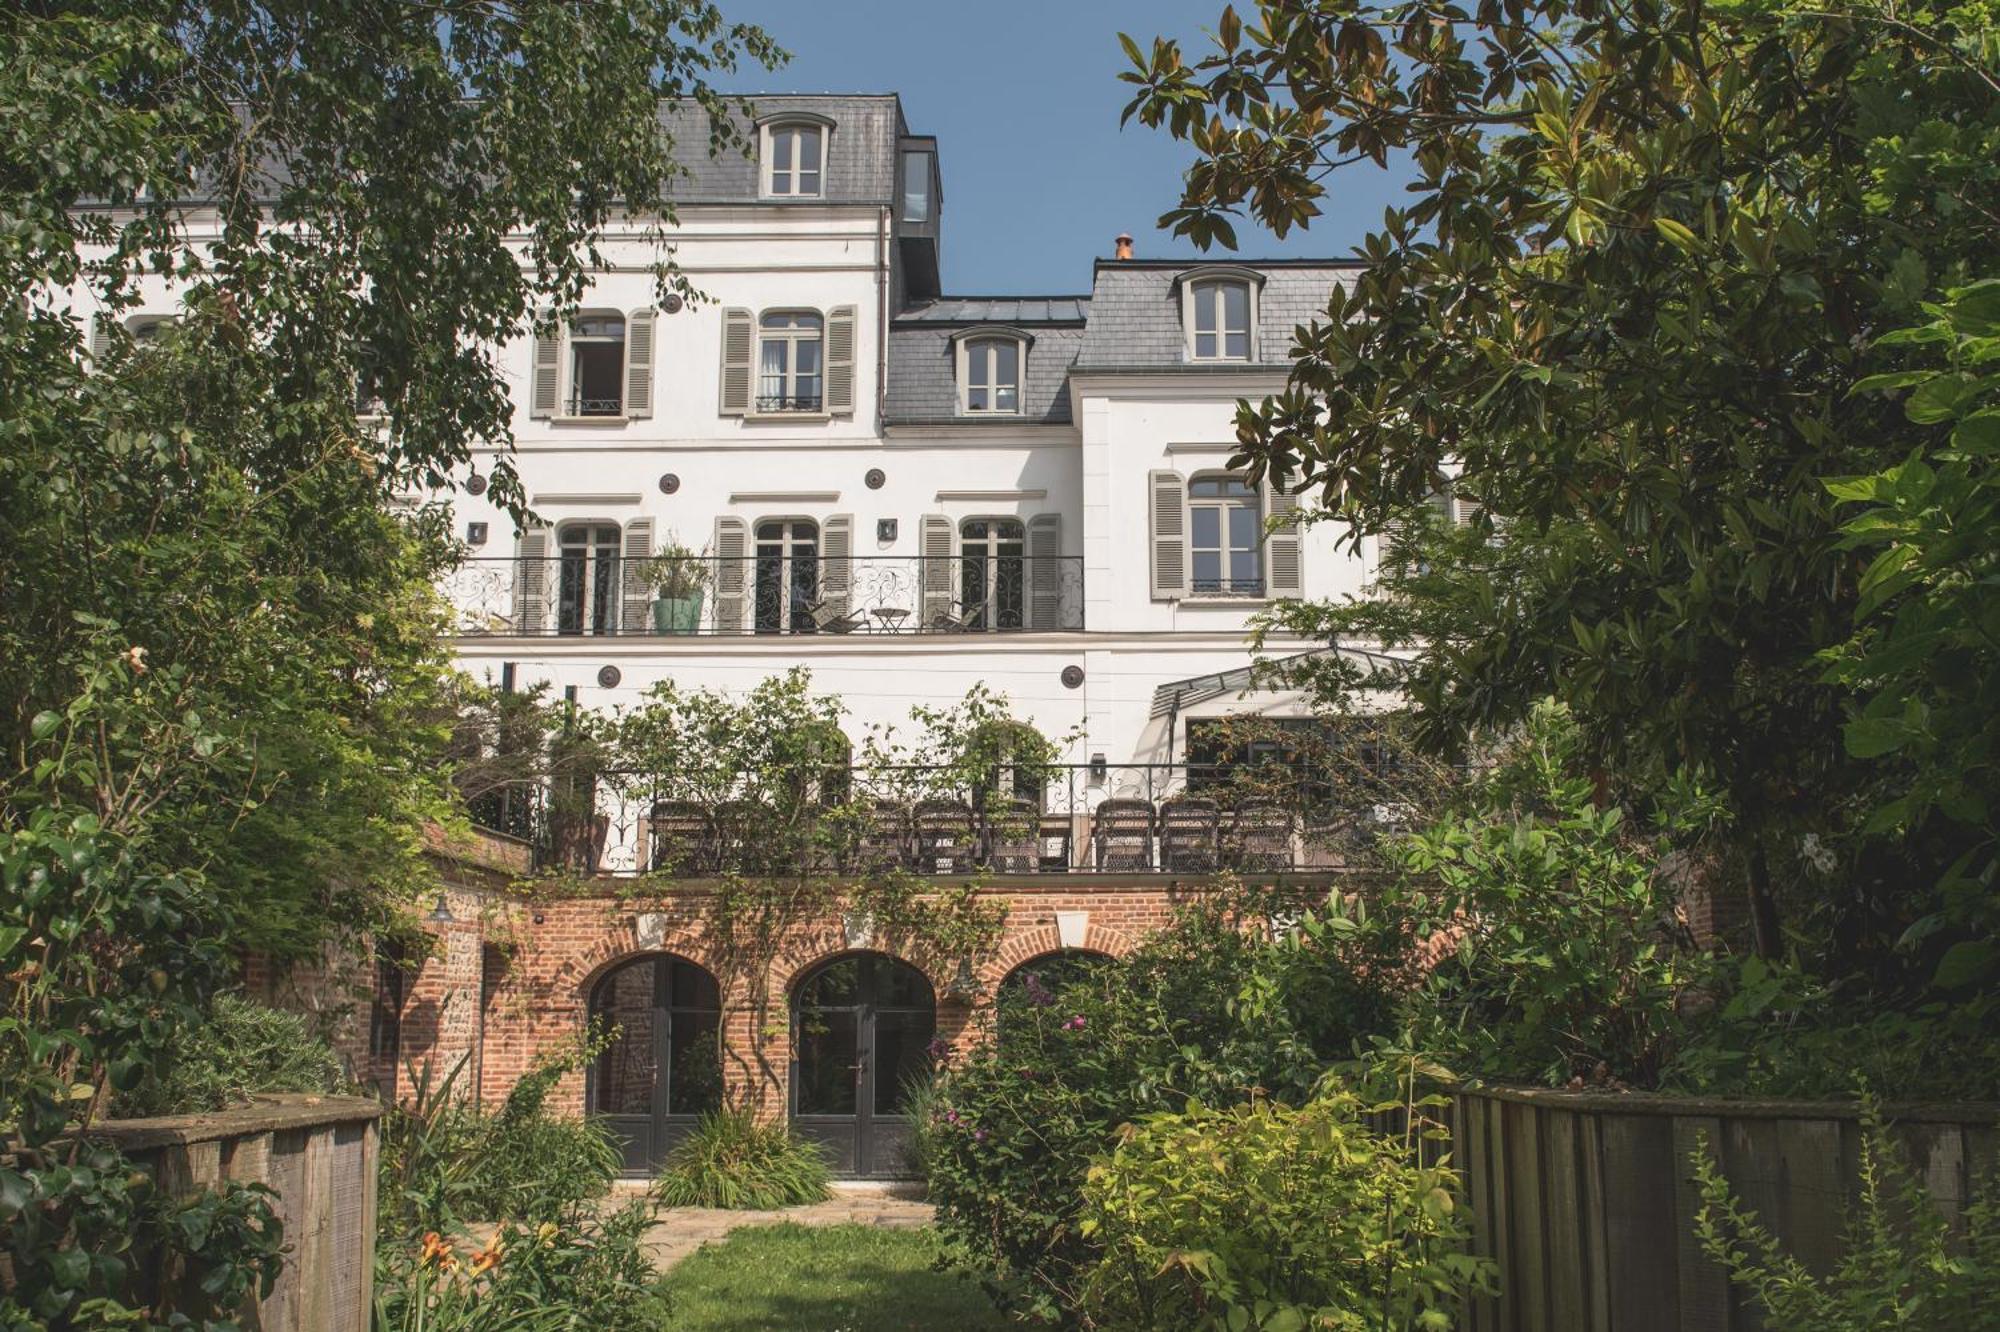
[722,0,1404,296]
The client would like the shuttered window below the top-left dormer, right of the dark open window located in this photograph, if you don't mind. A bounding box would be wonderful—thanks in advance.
[720,306,854,416]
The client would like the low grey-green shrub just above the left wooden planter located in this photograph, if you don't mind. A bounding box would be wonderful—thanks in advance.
[116,994,348,1118]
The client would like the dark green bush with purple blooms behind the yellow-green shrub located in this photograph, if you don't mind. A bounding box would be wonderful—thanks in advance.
[918,890,1402,1318]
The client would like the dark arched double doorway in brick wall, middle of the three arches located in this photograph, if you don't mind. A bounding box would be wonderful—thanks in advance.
[792,952,938,1178]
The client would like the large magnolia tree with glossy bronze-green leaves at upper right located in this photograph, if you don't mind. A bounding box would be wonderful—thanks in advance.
[1124,0,2000,968]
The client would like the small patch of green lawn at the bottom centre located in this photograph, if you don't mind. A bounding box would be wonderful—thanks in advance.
[662,1222,1010,1332]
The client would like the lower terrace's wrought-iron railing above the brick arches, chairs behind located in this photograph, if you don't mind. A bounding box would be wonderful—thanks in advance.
[474,762,1436,878]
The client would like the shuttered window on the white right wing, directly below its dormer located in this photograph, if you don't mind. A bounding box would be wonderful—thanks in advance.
[1146,470,1304,602]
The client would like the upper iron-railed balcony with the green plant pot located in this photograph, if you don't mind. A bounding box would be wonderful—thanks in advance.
[442,548,1084,638]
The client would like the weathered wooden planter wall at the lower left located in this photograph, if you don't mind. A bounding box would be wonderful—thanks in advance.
[90,1096,382,1332]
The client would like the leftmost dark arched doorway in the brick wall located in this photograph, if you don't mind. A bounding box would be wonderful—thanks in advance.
[584,954,722,1174]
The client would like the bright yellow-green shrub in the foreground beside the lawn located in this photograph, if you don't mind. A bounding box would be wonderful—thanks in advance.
[1080,1092,1494,1332]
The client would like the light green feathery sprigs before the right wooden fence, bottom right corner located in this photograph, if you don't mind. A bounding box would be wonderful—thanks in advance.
[1692,1098,2000,1332]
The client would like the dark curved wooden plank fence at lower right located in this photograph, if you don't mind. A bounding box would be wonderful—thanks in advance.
[1450,1088,2000,1332]
